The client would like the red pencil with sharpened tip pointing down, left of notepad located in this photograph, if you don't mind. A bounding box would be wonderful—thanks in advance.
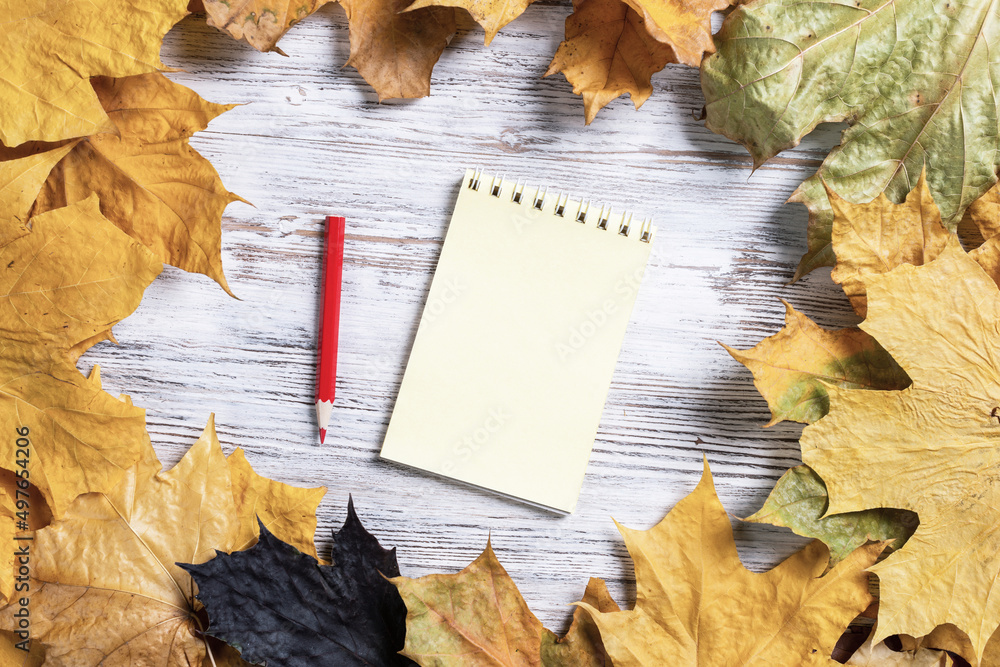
[316,215,344,443]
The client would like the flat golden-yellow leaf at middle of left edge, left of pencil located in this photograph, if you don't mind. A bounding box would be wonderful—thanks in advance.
[0,196,161,516]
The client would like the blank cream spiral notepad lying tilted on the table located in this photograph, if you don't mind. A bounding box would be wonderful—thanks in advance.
[382,170,655,512]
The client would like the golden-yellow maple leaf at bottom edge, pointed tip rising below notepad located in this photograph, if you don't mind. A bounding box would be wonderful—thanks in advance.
[581,461,885,667]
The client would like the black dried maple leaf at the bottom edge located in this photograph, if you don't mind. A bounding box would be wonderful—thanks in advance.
[179,500,414,667]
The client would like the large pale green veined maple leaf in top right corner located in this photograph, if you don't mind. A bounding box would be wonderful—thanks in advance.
[701,0,1000,275]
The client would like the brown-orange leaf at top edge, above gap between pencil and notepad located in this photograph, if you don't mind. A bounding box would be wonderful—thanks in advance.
[340,0,455,102]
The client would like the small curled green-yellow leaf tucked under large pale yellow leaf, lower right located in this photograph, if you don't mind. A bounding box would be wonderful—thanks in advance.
[745,466,918,564]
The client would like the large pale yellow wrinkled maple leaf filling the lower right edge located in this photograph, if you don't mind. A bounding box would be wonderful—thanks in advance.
[801,240,1000,658]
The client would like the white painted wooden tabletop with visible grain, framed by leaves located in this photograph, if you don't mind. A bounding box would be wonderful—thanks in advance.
[80,1,857,631]
